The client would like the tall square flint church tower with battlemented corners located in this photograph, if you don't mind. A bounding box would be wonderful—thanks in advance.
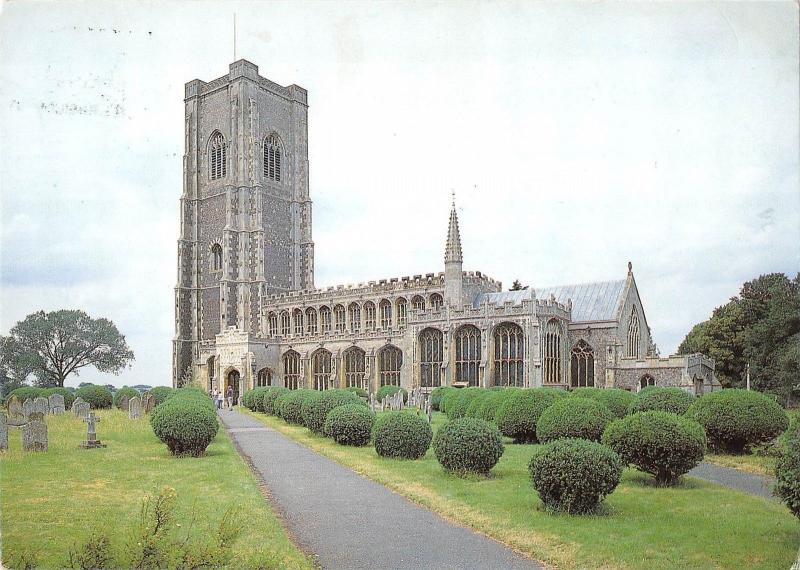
[172,60,314,385]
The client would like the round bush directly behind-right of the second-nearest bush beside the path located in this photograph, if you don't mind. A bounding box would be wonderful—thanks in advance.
[495,388,565,443]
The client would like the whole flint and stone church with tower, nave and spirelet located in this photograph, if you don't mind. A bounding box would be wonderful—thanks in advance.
[172,60,719,395]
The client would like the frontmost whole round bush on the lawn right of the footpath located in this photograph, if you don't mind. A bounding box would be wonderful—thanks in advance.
[528,439,622,514]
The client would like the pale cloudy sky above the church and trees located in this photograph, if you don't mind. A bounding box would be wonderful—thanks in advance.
[0,1,800,386]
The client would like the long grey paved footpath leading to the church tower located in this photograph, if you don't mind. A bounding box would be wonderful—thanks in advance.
[220,411,542,570]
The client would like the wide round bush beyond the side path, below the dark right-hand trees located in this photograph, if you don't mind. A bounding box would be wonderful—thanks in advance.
[686,388,789,453]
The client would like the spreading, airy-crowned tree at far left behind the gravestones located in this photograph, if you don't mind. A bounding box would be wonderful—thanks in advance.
[2,310,134,386]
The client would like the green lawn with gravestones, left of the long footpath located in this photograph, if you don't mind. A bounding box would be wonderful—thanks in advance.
[0,410,313,568]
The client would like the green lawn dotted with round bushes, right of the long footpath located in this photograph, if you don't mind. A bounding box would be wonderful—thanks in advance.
[243,410,800,569]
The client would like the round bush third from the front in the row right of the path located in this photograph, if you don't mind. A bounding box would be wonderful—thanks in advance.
[372,412,433,459]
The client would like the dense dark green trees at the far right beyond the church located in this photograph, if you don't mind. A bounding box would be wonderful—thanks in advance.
[678,273,800,403]
